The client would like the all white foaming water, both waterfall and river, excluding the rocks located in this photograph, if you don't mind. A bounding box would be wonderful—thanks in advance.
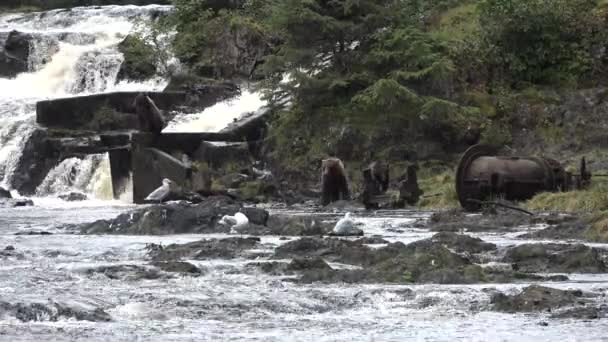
[0,6,608,341]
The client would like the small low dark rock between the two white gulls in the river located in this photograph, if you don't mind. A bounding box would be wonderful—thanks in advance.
[267,214,333,236]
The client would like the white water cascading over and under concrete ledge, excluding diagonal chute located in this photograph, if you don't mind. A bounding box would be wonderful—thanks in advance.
[0,5,171,197]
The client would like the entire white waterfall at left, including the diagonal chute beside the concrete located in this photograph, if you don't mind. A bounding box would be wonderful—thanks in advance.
[0,5,265,200]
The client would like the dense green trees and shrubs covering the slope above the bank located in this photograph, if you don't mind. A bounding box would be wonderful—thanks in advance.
[140,0,608,208]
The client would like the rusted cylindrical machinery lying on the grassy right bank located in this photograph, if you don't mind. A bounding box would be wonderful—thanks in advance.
[456,145,591,211]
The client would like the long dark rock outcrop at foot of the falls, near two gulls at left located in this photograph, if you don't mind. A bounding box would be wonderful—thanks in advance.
[80,197,267,235]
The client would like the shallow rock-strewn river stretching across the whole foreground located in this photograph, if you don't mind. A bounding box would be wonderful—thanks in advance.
[0,197,608,341]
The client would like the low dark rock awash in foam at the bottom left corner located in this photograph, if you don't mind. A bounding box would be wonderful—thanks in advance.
[0,300,112,322]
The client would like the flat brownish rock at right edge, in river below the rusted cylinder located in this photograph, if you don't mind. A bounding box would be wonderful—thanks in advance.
[503,244,606,273]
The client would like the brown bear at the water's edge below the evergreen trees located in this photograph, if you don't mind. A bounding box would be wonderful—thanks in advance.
[321,158,350,205]
